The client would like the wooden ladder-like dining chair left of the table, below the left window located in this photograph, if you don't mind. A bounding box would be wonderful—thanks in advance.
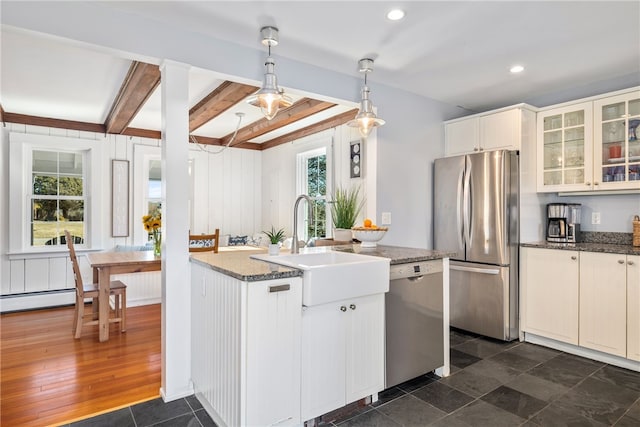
[64,230,127,338]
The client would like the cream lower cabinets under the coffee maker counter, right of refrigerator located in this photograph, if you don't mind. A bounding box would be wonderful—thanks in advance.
[520,248,640,361]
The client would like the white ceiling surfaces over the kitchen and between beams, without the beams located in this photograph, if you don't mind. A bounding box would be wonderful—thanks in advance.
[0,0,640,142]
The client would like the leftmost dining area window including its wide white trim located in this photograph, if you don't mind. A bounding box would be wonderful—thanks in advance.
[9,132,108,256]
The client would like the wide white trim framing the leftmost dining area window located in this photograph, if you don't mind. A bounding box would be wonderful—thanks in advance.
[9,132,105,255]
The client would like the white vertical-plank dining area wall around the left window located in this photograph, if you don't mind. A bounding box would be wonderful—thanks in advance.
[0,123,262,295]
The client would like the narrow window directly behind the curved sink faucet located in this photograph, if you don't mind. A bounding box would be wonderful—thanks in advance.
[298,148,327,239]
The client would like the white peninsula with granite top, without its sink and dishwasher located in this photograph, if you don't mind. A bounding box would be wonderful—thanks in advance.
[191,244,449,425]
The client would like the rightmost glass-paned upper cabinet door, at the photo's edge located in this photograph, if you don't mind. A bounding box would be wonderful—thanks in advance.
[594,91,640,189]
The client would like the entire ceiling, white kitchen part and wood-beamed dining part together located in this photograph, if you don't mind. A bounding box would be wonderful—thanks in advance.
[0,0,640,145]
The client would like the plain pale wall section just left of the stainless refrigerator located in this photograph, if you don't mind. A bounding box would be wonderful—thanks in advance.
[371,83,456,248]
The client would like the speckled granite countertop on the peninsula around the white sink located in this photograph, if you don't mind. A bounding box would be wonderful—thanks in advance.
[191,244,453,282]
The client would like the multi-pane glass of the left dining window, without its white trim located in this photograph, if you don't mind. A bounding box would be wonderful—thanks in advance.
[30,150,86,246]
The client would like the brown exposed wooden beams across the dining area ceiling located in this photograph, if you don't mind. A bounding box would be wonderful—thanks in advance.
[0,61,357,150]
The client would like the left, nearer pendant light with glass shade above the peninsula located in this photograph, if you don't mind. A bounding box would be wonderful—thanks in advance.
[247,27,293,120]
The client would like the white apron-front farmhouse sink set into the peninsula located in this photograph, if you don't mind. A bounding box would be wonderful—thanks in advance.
[251,251,390,306]
